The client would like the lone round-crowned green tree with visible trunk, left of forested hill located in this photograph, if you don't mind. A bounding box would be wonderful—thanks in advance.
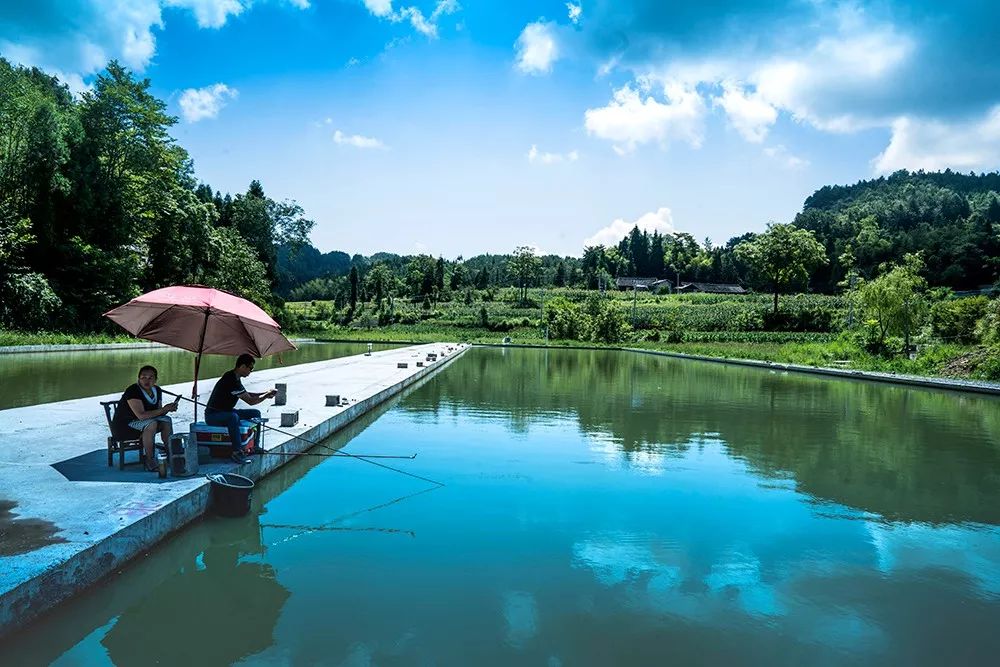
[734,224,827,313]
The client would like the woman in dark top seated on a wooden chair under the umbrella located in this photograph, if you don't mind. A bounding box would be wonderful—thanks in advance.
[111,366,177,471]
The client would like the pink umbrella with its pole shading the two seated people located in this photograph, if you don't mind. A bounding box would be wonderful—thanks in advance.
[104,285,295,421]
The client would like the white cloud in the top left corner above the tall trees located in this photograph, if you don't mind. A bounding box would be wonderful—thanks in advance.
[0,0,308,83]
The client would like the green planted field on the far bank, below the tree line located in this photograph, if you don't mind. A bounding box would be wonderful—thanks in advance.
[287,288,1000,379]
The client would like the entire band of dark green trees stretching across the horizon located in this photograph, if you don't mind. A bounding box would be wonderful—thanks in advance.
[0,59,1000,330]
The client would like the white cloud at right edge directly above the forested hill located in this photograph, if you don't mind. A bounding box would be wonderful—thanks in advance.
[872,105,1000,174]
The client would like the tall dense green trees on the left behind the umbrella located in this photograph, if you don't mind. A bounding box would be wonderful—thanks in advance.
[0,59,313,331]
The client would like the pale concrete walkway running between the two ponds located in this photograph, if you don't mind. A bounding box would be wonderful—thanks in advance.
[0,343,467,636]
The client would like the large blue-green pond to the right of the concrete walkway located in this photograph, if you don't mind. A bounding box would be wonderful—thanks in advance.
[0,348,1000,666]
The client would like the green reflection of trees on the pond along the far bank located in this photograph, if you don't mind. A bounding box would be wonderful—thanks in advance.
[405,349,1000,524]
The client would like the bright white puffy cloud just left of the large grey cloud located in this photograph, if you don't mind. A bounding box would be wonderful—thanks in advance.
[584,82,705,154]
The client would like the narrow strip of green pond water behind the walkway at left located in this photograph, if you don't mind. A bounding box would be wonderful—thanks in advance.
[0,343,399,410]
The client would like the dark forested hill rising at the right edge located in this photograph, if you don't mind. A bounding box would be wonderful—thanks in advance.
[794,170,1000,291]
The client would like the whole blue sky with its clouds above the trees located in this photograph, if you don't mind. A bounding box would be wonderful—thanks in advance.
[0,0,1000,258]
